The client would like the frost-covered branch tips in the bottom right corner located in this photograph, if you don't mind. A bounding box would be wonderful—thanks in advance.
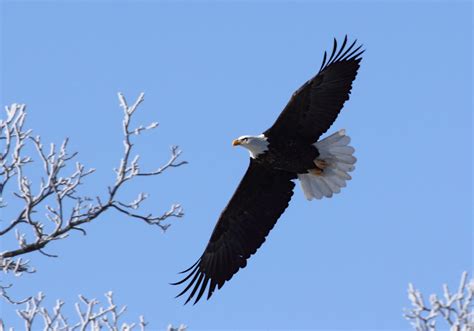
[404,272,474,331]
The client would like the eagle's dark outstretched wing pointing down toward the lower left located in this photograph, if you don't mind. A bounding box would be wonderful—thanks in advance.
[173,159,296,303]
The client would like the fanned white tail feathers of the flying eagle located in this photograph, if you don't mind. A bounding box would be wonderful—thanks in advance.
[298,130,357,200]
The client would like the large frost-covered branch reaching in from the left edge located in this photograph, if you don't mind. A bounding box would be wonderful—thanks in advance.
[0,93,186,278]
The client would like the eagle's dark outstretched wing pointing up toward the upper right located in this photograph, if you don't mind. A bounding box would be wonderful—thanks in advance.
[264,36,364,143]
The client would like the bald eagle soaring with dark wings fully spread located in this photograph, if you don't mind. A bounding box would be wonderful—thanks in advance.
[172,36,364,304]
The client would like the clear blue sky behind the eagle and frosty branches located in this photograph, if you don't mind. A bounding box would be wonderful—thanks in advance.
[1,1,473,330]
